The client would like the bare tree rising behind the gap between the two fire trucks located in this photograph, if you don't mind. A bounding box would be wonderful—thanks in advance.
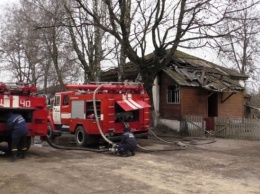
[21,0,79,89]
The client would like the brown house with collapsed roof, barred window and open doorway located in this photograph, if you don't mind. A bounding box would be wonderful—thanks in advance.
[101,51,248,130]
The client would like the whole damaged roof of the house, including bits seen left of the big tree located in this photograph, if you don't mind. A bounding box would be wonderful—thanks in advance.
[101,51,248,92]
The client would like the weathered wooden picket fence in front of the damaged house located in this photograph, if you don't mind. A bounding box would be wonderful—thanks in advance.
[180,115,260,140]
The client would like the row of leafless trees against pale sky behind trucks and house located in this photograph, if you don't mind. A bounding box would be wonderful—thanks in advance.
[1,0,259,96]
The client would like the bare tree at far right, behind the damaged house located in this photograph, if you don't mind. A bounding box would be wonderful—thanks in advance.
[212,0,260,91]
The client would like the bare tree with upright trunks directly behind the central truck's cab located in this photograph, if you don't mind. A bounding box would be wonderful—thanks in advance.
[64,0,105,82]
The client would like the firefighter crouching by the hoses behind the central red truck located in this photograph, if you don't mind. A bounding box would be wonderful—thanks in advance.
[118,127,137,157]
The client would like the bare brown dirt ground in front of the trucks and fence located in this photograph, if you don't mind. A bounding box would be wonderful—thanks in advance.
[0,133,260,194]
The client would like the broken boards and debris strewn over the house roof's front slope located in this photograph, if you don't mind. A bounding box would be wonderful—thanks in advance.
[163,55,248,92]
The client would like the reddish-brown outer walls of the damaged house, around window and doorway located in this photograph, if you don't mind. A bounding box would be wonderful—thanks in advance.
[159,72,244,120]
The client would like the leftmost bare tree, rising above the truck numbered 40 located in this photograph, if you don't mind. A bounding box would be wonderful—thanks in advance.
[1,4,44,84]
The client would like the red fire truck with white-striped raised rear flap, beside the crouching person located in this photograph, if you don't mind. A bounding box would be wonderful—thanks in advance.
[47,83,150,147]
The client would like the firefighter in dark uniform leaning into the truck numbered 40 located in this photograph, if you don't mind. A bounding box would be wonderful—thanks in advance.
[6,113,28,162]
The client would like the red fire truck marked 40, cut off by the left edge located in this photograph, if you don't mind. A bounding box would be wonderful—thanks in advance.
[0,82,48,149]
